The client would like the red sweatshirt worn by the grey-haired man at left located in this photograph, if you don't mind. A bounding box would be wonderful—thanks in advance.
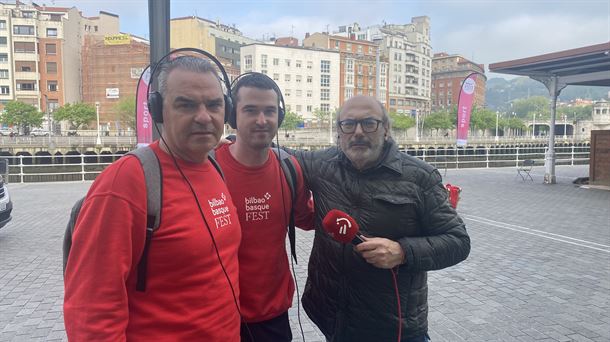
[64,143,241,341]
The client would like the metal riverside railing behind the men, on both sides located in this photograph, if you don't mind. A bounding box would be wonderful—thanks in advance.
[0,145,589,183]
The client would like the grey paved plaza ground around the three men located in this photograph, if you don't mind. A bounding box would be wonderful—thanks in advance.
[0,166,610,342]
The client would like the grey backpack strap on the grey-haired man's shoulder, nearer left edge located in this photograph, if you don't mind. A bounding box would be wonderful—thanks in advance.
[127,146,163,292]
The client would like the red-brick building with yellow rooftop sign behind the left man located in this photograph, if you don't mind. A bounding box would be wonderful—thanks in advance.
[83,34,150,131]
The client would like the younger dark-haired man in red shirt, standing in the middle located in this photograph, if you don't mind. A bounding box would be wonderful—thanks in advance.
[216,73,313,342]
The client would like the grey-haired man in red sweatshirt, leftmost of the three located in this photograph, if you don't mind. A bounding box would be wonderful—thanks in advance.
[64,56,241,342]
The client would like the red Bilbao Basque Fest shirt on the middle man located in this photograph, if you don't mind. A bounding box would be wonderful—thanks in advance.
[216,144,314,323]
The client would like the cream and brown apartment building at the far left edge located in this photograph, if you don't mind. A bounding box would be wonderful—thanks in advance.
[0,1,118,129]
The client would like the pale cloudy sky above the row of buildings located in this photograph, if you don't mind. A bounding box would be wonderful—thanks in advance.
[53,0,610,76]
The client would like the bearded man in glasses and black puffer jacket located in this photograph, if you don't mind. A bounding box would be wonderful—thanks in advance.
[294,96,470,342]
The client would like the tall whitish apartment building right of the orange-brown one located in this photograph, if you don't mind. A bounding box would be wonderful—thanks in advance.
[335,16,432,113]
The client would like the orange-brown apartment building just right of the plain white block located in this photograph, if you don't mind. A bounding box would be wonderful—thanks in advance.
[303,33,389,108]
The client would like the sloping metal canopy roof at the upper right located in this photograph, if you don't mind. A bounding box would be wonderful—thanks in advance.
[489,42,610,86]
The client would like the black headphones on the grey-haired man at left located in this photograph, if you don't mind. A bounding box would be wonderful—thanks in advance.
[147,48,233,123]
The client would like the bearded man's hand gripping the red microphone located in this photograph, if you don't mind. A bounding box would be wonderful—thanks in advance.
[355,238,405,269]
